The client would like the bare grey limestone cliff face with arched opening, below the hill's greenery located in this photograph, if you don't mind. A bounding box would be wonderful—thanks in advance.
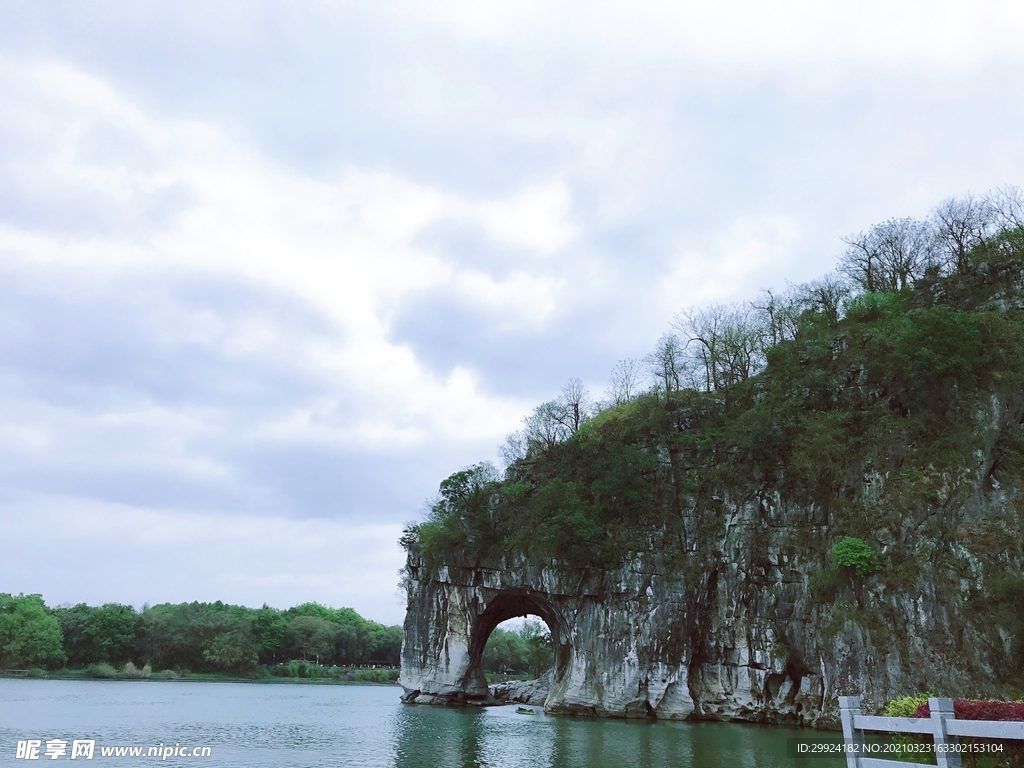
[399,490,1019,727]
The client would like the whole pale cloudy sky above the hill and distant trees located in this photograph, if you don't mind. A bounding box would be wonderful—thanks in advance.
[0,0,1024,624]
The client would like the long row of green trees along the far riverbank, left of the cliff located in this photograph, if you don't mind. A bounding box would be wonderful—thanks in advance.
[0,594,401,675]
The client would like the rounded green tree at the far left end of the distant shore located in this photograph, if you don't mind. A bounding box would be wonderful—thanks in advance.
[0,593,67,669]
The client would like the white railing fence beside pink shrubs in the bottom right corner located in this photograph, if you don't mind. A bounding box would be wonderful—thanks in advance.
[839,696,1024,768]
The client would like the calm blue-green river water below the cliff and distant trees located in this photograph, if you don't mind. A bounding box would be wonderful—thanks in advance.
[0,679,845,768]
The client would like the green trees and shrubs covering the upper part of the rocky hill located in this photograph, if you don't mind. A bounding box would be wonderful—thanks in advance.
[402,188,1024,684]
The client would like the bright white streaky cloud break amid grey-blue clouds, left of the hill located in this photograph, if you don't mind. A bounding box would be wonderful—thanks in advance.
[0,58,561,444]
